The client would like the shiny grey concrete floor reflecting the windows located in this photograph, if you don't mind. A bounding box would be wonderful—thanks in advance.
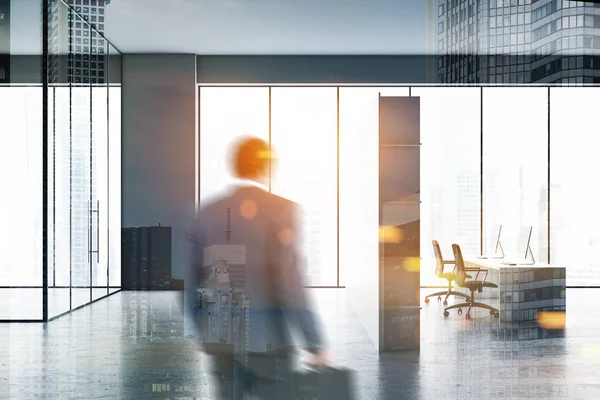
[0,289,600,400]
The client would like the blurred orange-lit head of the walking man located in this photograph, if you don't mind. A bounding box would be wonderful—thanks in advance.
[232,137,271,181]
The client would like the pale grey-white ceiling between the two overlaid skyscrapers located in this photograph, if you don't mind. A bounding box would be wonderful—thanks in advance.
[105,0,428,55]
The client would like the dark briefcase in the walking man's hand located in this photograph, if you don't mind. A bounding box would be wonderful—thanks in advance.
[296,368,355,400]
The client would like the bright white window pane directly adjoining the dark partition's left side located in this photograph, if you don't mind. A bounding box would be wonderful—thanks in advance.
[339,87,409,286]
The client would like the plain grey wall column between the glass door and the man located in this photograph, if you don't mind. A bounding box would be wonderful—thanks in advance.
[122,54,196,276]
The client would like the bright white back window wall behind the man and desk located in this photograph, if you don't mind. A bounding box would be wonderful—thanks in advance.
[199,87,600,286]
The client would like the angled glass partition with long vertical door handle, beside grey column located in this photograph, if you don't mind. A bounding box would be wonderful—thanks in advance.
[47,2,121,318]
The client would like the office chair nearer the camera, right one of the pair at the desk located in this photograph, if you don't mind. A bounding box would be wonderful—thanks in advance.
[444,244,500,319]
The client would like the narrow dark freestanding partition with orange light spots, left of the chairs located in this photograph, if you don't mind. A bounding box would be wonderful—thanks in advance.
[379,97,421,351]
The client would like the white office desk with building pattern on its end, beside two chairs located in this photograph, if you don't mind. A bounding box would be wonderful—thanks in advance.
[457,258,566,340]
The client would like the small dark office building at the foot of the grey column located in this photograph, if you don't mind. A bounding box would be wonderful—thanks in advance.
[121,225,172,290]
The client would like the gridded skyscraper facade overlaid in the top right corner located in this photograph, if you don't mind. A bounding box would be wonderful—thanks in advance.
[437,0,600,83]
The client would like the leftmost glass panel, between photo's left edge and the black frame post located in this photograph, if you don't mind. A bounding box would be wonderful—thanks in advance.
[0,0,44,321]
